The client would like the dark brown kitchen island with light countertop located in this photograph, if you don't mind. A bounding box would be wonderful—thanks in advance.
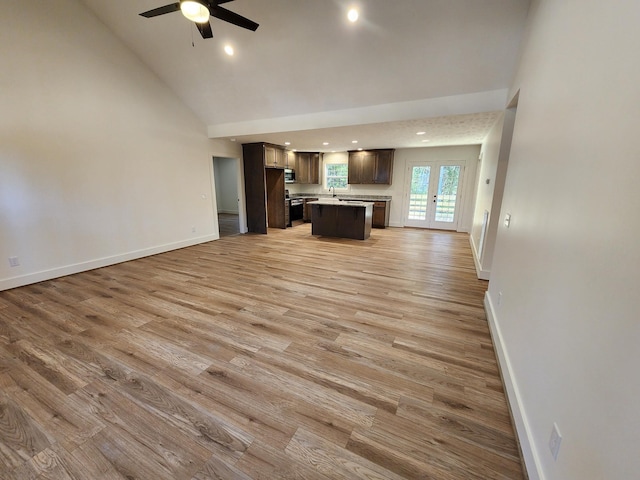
[309,198,373,240]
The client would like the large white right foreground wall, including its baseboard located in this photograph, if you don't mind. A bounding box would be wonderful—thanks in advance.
[487,0,640,480]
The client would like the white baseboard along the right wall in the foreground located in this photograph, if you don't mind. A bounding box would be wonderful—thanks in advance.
[484,291,546,480]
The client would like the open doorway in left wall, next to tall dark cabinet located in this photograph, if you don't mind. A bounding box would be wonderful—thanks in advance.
[213,157,242,237]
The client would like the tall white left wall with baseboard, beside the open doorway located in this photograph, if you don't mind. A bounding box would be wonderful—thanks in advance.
[0,0,240,289]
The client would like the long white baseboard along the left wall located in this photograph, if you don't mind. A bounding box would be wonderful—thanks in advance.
[0,233,220,292]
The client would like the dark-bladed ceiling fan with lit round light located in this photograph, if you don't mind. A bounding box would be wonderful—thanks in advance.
[140,0,259,38]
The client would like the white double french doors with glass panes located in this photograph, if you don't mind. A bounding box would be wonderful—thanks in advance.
[404,161,464,230]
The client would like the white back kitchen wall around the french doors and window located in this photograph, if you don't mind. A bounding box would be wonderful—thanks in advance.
[287,145,480,232]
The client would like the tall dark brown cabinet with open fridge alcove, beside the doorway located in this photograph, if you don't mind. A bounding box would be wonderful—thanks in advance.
[242,143,286,233]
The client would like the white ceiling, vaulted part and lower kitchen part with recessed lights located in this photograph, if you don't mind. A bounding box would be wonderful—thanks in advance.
[81,0,529,151]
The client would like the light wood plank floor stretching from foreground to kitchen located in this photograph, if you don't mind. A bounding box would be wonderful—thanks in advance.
[0,224,523,480]
